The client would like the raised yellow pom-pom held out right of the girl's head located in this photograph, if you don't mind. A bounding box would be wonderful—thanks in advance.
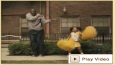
[81,26,97,40]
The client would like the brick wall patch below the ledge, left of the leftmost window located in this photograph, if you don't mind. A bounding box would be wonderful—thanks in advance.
[1,16,20,34]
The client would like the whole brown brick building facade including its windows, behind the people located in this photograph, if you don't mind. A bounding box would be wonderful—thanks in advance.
[1,1,113,35]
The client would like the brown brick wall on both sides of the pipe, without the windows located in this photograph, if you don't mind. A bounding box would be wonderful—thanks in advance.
[2,1,112,33]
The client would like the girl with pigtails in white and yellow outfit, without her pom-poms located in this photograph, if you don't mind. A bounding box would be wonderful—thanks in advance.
[68,27,83,54]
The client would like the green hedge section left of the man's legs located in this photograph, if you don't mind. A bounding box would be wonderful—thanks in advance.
[8,42,31,55]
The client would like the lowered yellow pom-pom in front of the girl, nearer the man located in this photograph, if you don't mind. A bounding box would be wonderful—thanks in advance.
[57,40,75,51]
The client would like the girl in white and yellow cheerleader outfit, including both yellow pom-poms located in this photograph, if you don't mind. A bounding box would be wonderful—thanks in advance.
[57,26,97,54]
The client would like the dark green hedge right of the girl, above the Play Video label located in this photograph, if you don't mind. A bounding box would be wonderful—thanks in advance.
[72,41,112,54]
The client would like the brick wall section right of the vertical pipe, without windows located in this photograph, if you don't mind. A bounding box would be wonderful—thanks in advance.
[50,1,112,33]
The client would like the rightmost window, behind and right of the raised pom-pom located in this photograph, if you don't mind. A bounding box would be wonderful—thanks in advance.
[92,16,111,34]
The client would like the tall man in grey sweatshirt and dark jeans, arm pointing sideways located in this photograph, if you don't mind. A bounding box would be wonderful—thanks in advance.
[26,9,56,57]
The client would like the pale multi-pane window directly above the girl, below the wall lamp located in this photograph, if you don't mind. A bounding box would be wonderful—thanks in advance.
[61,17,80,33]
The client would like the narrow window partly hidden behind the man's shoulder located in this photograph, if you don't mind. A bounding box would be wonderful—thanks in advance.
[21,18,29,37]
